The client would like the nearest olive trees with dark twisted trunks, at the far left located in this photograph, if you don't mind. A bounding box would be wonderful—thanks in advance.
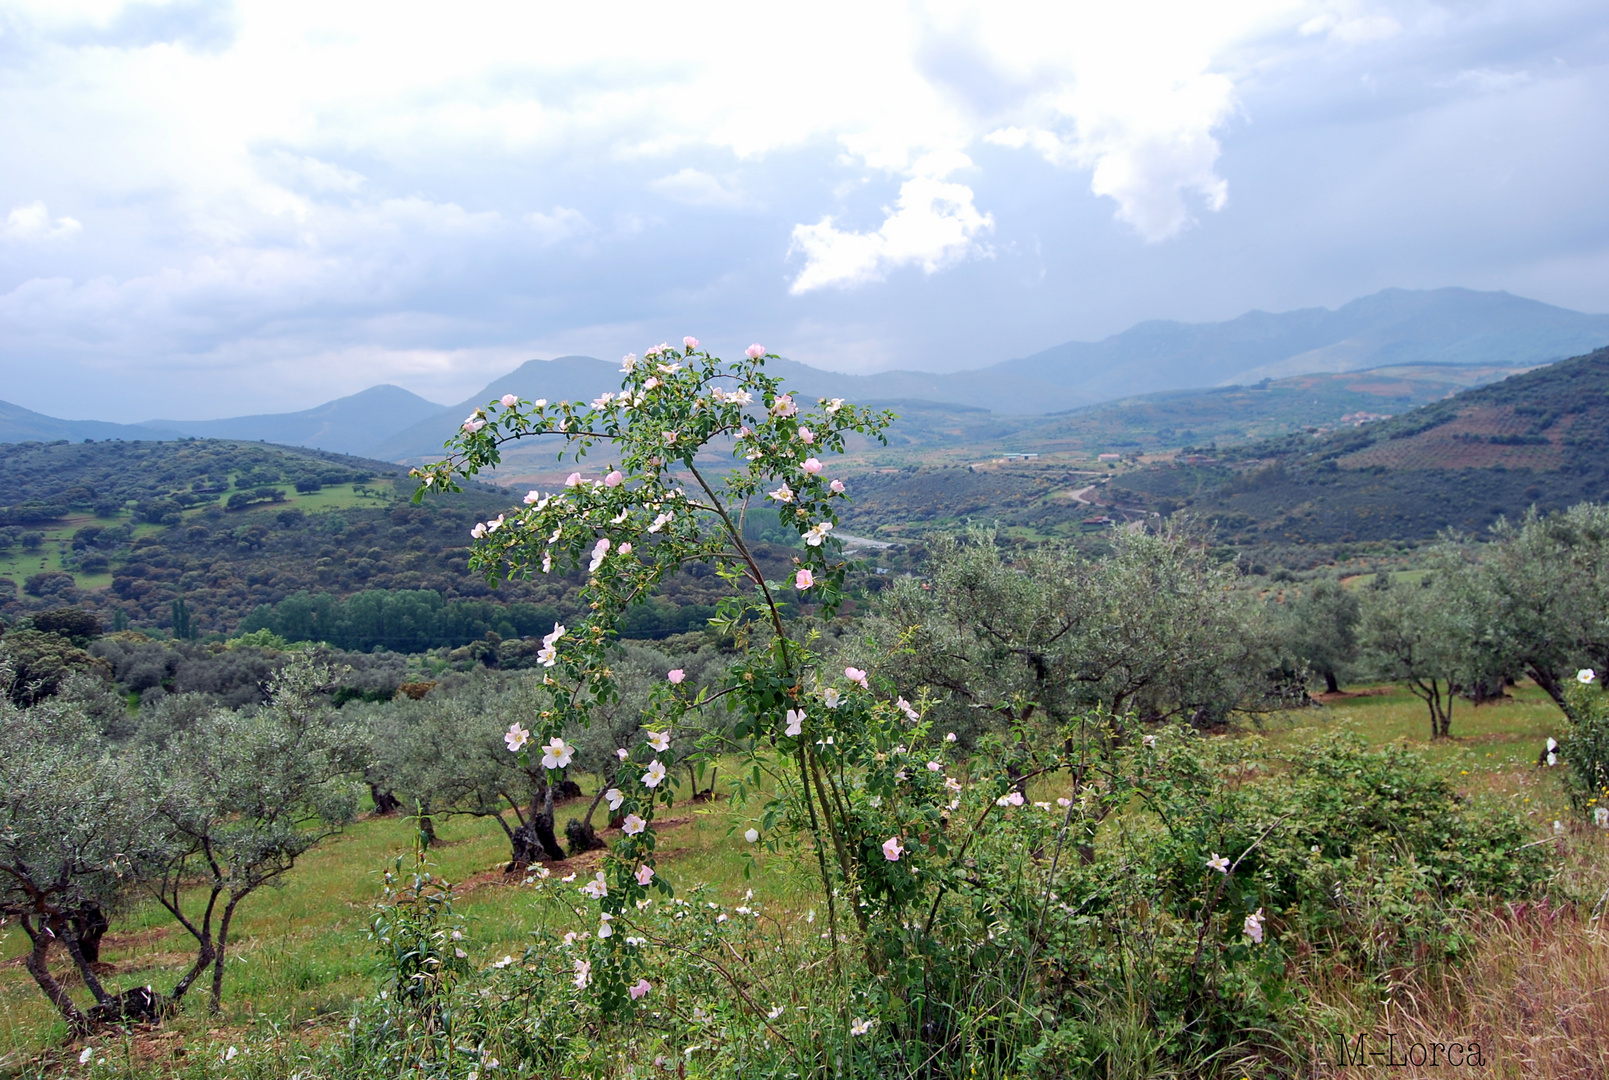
[0,657,367,1032]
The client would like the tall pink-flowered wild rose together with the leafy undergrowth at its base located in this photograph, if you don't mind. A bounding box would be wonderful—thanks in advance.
[386,349,1543,1077]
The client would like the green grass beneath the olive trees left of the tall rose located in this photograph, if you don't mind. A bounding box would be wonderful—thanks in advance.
[0,779,811,1075]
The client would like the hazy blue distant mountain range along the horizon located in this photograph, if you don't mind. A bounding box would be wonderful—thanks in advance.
[0,288,1609,462]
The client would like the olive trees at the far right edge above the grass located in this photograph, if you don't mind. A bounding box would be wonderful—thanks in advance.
[1279,502,1609,737]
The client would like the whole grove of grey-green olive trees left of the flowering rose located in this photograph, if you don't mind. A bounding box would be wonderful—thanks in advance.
[0,624,729,1030]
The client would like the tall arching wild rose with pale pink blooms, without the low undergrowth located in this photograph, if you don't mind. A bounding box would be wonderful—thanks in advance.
[415,338,1068,1024]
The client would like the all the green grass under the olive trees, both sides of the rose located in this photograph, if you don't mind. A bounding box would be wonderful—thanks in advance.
[0,686,1583,1075]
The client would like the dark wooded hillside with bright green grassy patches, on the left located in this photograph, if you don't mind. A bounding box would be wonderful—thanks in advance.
[0,439,804,652]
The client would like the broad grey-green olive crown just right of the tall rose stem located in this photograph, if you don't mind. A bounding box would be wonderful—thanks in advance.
[872,528,1276,743]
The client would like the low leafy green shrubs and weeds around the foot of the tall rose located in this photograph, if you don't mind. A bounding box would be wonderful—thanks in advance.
[328,728,1548,1078]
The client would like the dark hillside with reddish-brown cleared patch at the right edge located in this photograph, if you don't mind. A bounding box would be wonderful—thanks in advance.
[1102,349,1609,544]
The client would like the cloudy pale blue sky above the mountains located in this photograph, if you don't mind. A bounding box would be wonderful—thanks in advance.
[0,0,1609,422]
